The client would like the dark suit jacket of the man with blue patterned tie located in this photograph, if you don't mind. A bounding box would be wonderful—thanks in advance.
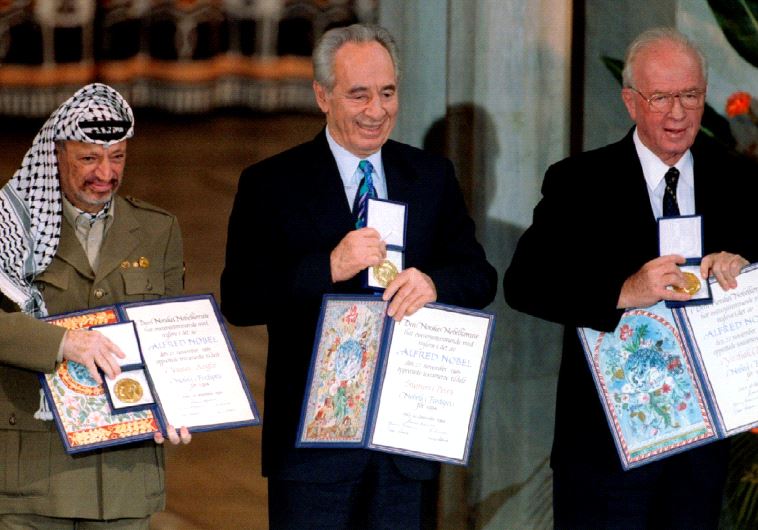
[221,131,497,482]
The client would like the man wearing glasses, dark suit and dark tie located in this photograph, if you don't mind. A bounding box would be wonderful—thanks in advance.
[503,28,758,528]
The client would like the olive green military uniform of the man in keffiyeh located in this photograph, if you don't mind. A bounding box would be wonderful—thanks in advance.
[0,197,183,519]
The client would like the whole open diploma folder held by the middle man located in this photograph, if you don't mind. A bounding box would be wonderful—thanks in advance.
[297,295,494,465]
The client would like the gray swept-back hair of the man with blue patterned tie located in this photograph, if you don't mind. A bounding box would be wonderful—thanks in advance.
[313,24,400,90]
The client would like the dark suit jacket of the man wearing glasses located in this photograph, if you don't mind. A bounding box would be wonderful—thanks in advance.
[503,132,758,471]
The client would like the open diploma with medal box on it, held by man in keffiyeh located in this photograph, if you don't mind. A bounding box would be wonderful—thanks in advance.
[40,295,260,453]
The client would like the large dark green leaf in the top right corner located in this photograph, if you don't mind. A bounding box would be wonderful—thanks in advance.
[708,0,758,67]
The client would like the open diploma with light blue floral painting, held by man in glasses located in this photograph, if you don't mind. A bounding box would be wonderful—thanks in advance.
[578,264,758,469]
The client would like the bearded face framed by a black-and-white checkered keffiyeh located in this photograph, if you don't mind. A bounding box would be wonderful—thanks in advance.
[56,140,126,213]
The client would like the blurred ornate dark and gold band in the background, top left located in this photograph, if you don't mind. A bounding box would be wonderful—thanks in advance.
[0,0,377,116]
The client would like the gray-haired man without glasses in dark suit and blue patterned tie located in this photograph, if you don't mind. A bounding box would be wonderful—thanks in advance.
[221,24,497,528]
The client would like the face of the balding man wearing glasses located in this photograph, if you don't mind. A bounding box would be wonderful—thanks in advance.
[621,40,706,166]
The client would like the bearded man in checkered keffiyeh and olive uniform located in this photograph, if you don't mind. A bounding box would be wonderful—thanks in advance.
[0,84,190,528]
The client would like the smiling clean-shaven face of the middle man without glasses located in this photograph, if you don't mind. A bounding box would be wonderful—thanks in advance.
[313,42,398,158]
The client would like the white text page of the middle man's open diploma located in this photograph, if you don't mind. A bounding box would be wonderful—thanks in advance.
[371,307,491,461]
